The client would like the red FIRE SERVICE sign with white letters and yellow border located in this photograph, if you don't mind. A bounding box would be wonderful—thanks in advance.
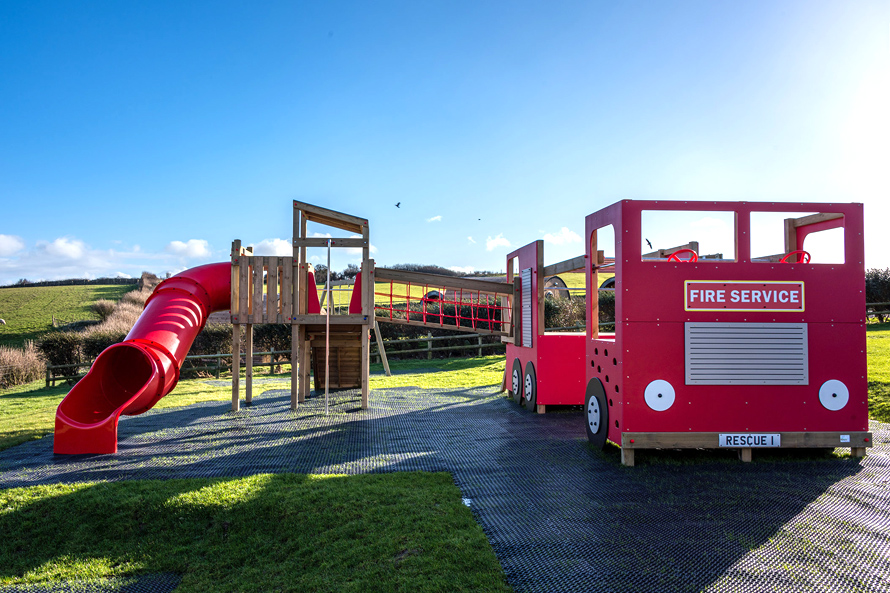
[684,280,804,311]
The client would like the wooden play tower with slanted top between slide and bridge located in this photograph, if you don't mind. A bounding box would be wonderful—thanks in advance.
[230,201,374,410]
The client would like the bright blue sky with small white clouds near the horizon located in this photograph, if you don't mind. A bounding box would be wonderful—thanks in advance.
[0,0,890,284]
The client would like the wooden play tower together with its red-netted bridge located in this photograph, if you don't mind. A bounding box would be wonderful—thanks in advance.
[230,201,514,411]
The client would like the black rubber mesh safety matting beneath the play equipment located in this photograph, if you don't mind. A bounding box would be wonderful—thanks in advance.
[0,387,890,593]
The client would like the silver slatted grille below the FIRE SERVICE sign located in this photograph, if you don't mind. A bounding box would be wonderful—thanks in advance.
[686,323,809,385]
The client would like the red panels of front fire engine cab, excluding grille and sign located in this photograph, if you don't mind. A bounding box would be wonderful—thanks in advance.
[584,201,868,444]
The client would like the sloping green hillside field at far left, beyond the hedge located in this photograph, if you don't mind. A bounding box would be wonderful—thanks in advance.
[0,284,136,346]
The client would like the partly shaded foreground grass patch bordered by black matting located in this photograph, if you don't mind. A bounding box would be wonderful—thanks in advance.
[0,472,511,592]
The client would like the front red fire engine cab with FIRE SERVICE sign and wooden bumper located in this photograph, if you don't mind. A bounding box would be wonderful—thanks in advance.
[584,200,871,465]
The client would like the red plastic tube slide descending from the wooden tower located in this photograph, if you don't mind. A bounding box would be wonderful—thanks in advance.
[53,263,232,455]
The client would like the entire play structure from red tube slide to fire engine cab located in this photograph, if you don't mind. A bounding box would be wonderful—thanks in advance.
[54,200,871,465]
